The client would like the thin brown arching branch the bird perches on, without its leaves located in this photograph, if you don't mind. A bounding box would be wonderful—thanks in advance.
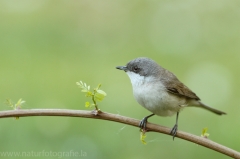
[0,109,240,159]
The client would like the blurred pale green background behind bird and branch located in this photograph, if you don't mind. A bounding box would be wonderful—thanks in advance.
[0,0,240,159]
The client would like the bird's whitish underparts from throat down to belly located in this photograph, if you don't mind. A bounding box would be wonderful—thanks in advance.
[127,71,186,116]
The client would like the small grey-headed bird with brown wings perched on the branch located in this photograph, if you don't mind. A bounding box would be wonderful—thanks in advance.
[116,57,226,139]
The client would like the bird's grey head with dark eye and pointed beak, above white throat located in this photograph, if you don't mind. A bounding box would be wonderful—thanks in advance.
[116,57,161,78]
